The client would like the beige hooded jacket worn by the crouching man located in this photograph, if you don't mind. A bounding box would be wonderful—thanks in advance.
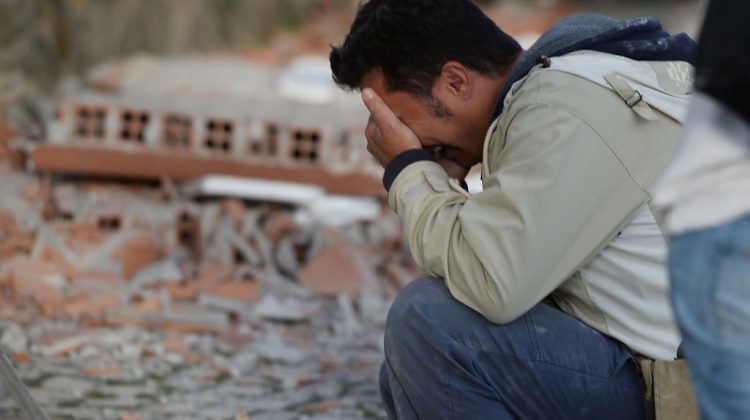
[388,52,690,358]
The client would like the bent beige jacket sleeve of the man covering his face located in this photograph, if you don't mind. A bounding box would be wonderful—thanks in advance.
[388,104,645,323]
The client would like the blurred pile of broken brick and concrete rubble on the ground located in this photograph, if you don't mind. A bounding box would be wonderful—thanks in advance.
[0,170,419,419]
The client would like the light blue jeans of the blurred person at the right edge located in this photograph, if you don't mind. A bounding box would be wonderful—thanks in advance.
[669,217,750,420]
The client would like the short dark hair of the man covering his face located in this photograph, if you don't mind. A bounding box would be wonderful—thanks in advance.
[330,0,521,98]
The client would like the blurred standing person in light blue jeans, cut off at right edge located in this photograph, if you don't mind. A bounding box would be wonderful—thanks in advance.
[655,0,750,420]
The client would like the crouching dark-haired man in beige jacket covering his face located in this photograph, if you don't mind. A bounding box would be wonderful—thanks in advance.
[330,0,695,420]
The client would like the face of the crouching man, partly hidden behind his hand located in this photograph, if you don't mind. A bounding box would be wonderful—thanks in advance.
[361,71,486,170]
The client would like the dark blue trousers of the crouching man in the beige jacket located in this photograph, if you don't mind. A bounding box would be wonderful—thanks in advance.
[380,278,645,420]
